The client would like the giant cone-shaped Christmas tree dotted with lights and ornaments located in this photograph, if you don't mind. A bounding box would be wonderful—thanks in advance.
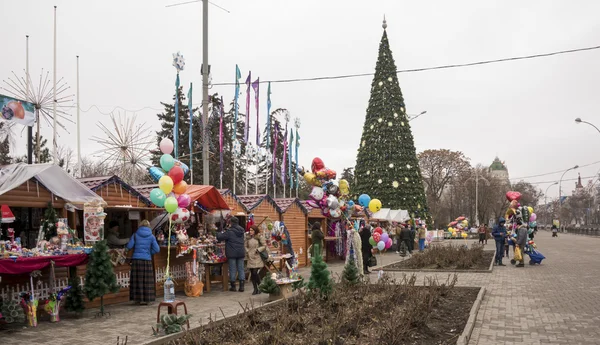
[354,21,429,218]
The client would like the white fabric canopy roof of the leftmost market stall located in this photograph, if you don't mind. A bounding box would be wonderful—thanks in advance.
[0,163,105,205]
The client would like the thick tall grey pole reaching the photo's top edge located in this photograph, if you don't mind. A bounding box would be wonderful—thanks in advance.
[202,0,210,185]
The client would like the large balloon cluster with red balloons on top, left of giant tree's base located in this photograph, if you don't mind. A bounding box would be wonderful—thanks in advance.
[298,157,382,218]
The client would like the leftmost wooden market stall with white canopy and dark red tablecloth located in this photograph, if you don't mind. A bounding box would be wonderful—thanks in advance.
[0,163,104,308]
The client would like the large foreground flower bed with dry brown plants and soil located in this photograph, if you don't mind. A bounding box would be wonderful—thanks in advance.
[168,275,480,345]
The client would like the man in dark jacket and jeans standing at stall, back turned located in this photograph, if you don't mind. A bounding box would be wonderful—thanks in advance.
[217,217,246,292]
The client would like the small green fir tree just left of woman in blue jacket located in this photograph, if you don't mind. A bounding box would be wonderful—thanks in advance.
[83,240,119,316]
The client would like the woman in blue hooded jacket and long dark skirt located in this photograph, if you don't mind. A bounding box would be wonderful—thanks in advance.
[127,220,160,304]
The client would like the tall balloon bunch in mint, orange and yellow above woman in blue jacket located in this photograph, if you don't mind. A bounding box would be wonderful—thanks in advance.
[148,138,192,223]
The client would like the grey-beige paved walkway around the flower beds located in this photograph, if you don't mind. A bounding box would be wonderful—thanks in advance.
[0,231,600,345]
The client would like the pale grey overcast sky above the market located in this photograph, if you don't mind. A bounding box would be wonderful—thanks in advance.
[0,0,600,196]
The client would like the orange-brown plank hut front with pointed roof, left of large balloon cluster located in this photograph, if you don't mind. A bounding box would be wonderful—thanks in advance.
[275,198,309,267]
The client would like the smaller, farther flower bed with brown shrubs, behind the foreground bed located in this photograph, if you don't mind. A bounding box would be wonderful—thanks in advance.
[382,245,495,271]
